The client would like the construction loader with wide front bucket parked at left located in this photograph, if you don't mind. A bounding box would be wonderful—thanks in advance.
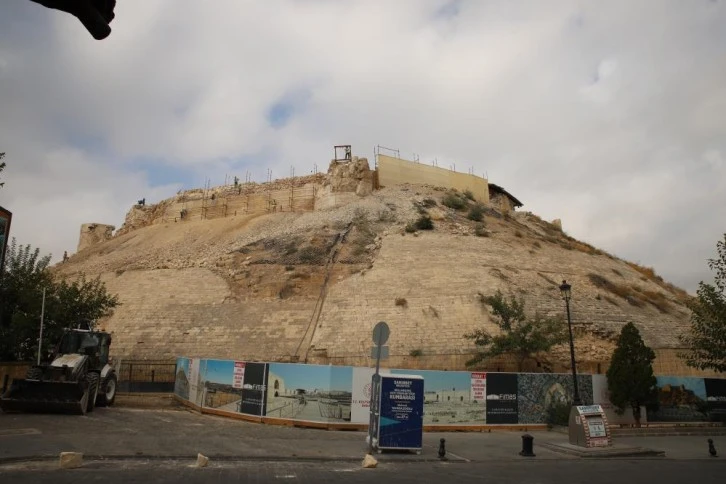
[0,329,117,415]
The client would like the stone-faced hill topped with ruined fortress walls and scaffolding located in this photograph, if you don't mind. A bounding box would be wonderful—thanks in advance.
[56,149,712,374]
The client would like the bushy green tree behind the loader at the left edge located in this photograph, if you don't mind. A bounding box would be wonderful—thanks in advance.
[0,239,118,361]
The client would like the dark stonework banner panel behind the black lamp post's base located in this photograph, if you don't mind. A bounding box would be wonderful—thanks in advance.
[517,373,593,423]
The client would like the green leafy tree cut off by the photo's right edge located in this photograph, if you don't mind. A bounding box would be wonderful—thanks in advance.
[679,234,726,372]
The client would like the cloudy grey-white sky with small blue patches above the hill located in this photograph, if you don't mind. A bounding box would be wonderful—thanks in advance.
[0,0,726,291]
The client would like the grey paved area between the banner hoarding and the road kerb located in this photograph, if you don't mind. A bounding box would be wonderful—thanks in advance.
[0,408,726,463]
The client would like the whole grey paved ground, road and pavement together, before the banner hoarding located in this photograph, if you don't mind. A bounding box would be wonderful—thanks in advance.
[0,408,726,484]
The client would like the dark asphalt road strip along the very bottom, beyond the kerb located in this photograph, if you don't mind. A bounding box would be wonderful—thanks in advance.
[0,459,726,484]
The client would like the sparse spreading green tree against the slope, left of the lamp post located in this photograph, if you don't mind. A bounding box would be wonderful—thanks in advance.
[464,291,567,371]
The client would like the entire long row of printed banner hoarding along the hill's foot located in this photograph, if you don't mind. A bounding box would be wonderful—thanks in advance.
[174,357,726,425]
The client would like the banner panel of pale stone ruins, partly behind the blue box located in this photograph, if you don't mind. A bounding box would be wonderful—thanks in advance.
[391,370,486,425]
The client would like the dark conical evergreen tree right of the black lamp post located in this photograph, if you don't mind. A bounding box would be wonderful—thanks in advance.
[606,323,657,427]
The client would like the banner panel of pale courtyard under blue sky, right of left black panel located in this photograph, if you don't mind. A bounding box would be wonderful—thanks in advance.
[265,363,353,423]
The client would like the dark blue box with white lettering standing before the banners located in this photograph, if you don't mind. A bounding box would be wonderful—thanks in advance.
[377,375,424,450]
